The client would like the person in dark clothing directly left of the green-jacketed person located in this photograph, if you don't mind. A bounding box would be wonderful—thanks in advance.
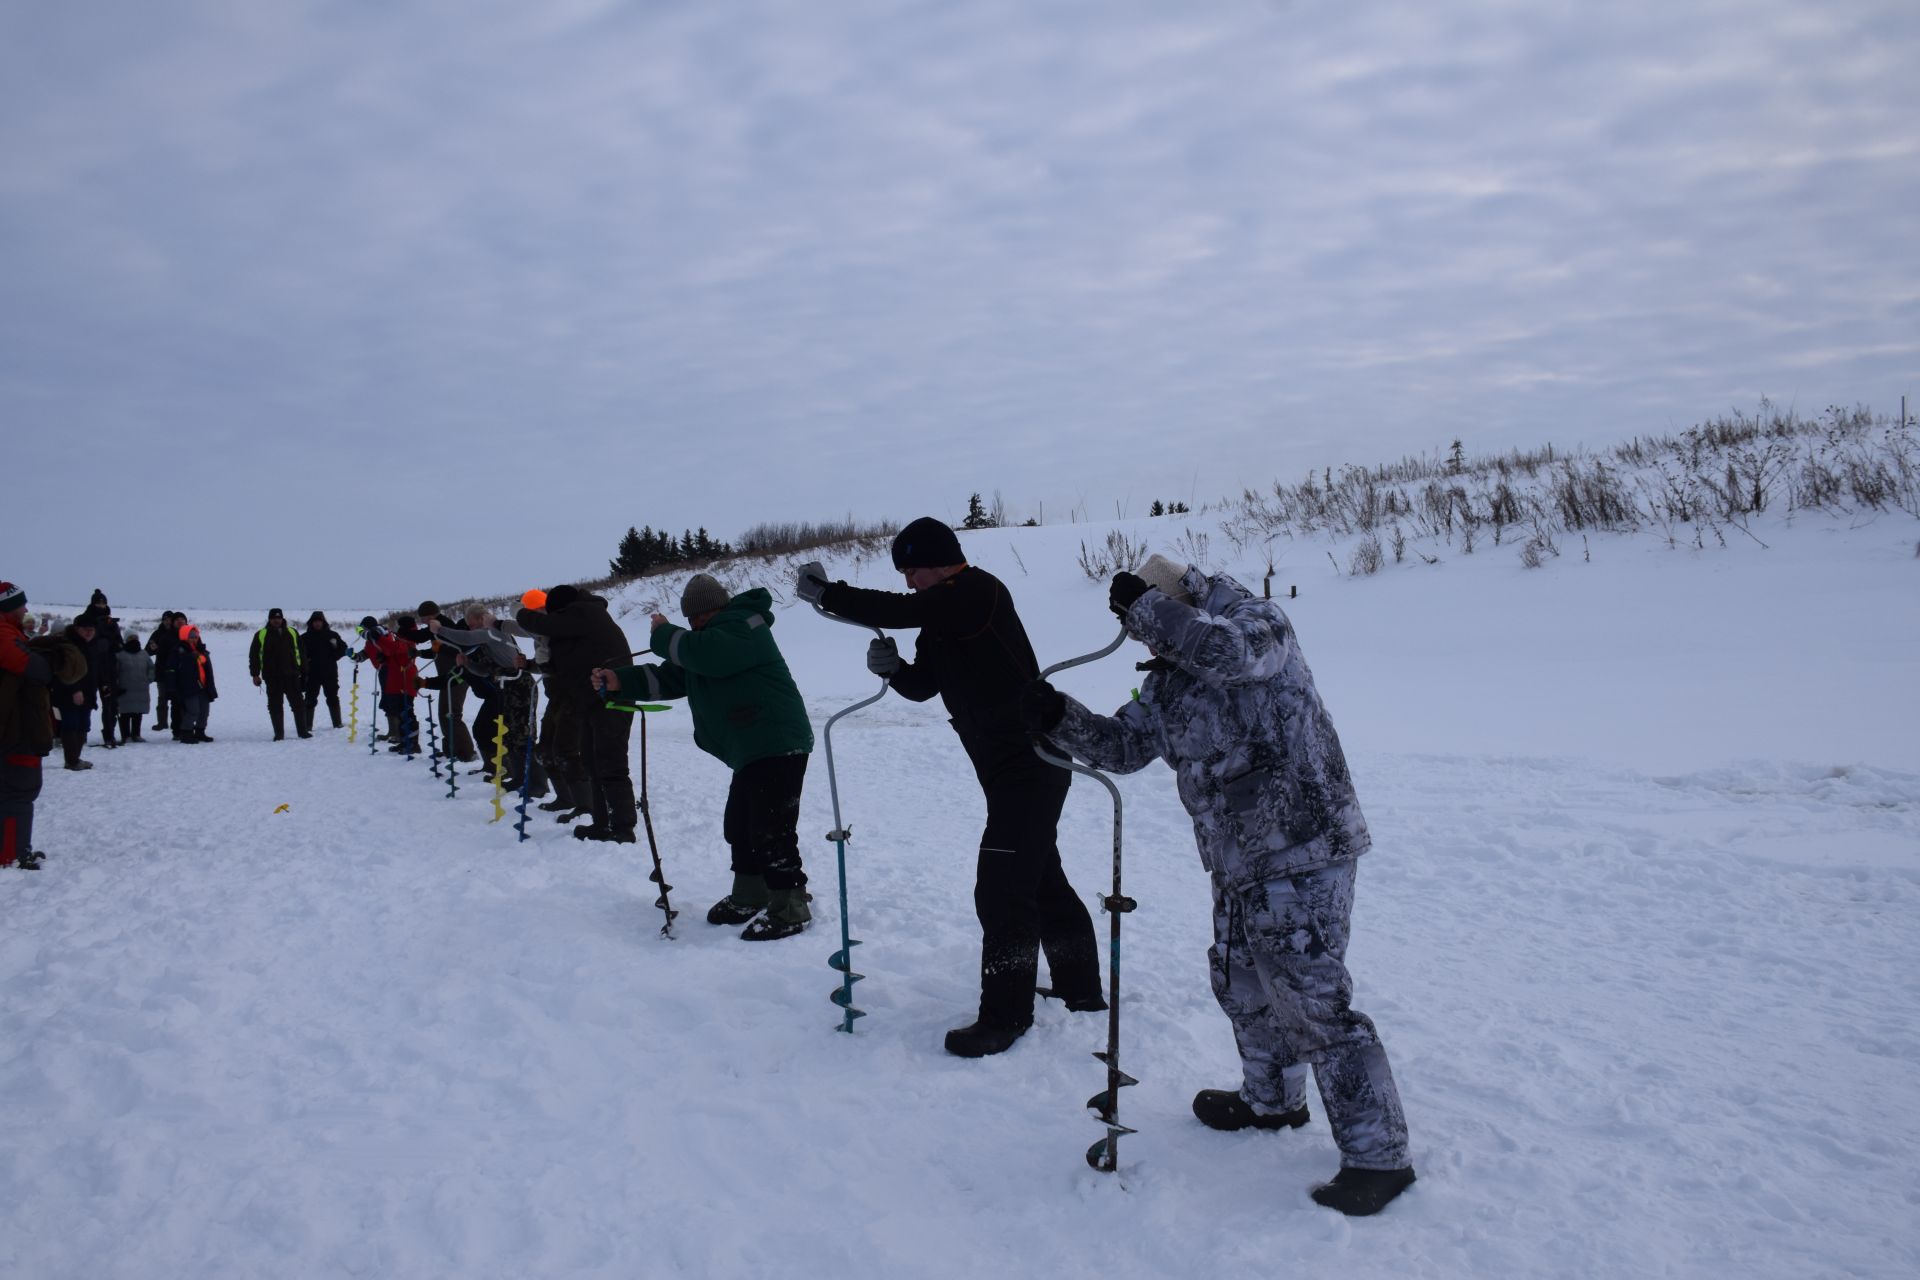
[515,585,639,842]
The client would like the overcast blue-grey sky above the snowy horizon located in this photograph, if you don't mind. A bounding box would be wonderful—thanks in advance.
[0,0,1920,608]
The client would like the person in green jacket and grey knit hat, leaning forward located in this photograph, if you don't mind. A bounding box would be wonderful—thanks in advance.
[593,574,814,942]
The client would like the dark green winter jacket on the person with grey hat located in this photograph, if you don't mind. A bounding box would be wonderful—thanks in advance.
[614,587,814,770]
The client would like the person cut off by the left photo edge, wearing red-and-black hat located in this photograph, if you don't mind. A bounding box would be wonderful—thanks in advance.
[0,581,86,871]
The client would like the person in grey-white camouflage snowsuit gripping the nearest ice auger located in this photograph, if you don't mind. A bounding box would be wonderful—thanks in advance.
[1021,557,1413,1213]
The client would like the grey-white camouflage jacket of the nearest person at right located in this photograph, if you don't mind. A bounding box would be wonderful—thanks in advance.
[1046,568,1371,885]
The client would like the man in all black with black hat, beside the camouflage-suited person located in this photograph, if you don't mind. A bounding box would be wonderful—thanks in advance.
[797,516,1106,1057]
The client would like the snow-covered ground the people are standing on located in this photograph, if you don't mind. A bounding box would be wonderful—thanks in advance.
[0,516,1920,1280]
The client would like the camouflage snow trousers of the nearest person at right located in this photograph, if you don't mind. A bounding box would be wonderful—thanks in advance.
[1208,860,1411,1169]
